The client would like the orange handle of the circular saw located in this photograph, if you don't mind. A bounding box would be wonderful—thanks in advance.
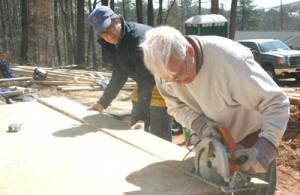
[219,126,241,172]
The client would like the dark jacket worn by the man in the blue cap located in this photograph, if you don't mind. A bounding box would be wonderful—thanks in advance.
[98,19,155,121]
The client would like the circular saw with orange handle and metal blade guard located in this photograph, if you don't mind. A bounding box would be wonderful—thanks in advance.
[187,127,268,193]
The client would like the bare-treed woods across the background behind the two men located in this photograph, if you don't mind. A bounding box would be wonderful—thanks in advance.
[0,0,300,68]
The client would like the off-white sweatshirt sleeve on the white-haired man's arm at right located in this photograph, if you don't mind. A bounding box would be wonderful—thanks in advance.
[217,56,290,146]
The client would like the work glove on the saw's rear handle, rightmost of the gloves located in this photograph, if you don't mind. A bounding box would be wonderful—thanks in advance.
[233,138,277,174]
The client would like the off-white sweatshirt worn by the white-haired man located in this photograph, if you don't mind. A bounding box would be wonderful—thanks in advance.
[156,36,289,146]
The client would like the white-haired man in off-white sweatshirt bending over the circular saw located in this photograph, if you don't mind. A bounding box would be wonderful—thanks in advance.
[140,26,289,195]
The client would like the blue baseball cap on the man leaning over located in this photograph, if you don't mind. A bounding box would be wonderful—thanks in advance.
[89,6,114,36]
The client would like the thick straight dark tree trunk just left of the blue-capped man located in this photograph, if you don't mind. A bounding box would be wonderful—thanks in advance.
[76,0,85,65]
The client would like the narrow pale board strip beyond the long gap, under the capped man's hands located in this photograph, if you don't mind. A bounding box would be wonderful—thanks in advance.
[39,97,192,160]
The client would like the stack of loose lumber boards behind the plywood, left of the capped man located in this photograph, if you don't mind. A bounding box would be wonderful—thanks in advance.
[11,66,135,91]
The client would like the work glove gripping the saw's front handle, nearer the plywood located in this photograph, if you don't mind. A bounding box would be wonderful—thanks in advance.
[192,117,223,142]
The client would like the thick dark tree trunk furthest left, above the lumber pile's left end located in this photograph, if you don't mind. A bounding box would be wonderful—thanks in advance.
[20,0,29,64]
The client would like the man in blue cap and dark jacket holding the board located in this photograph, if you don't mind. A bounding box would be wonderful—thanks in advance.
[88,6,172,141]
